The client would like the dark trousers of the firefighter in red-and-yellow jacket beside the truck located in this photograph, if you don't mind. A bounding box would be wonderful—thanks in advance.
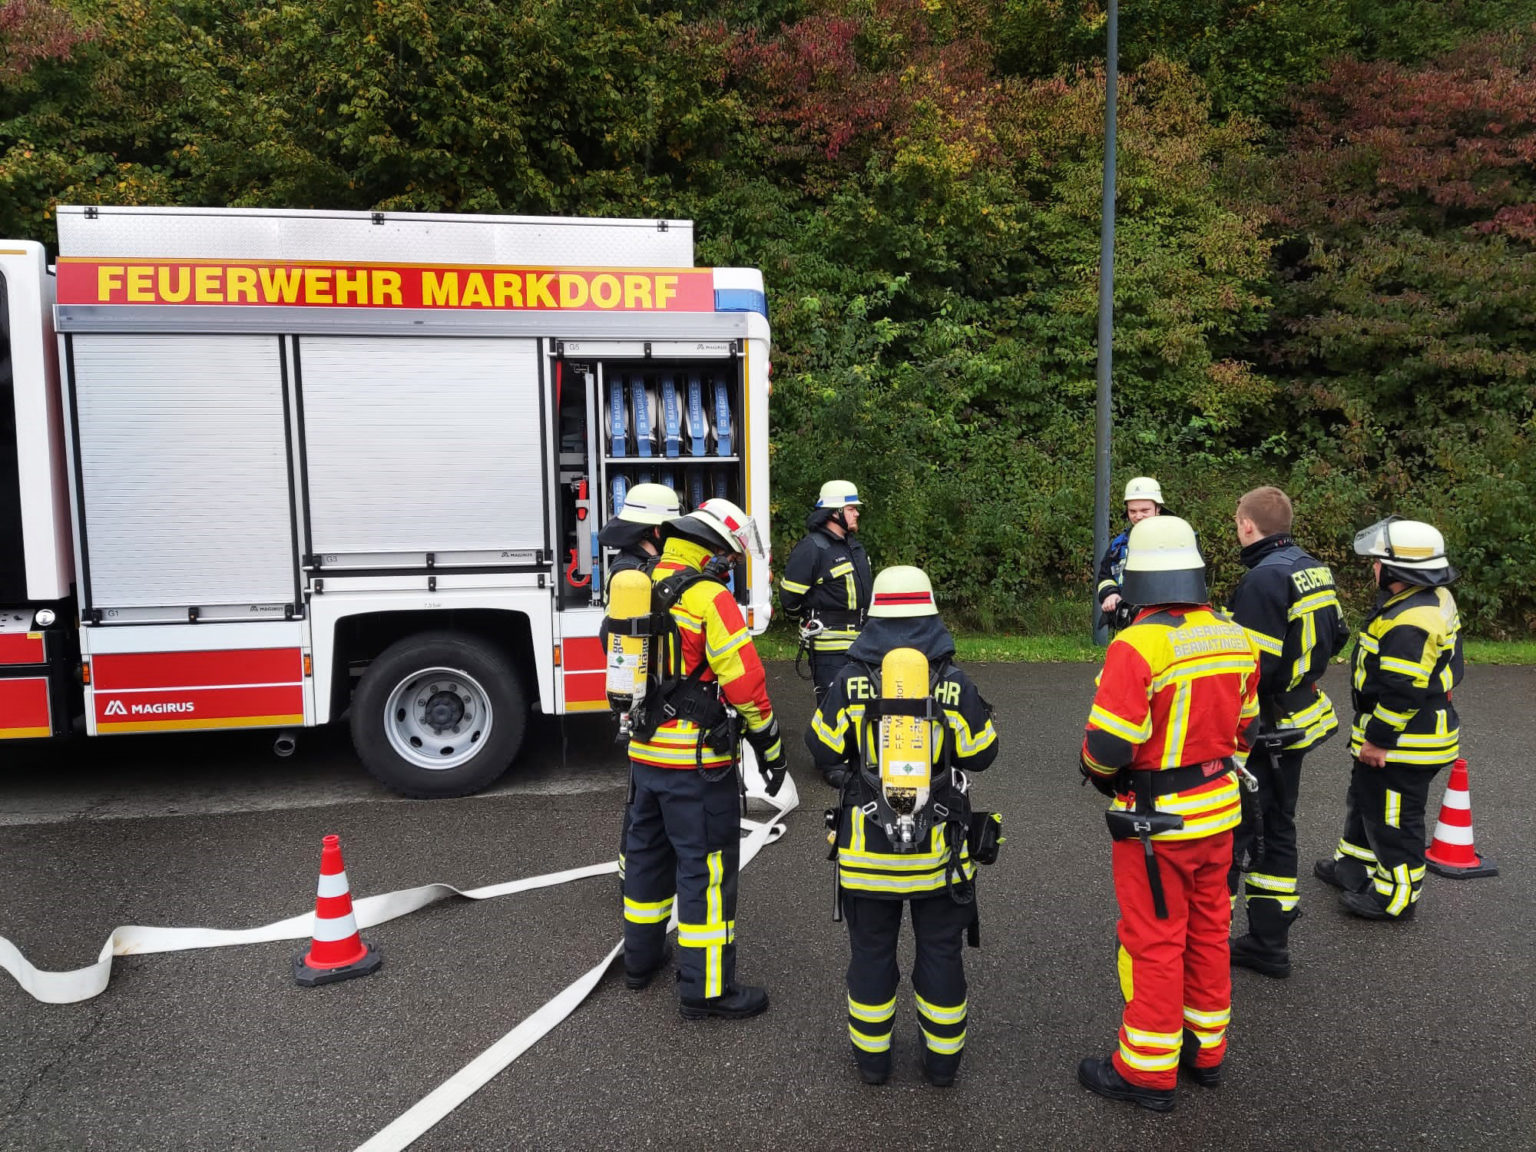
[624,760,742,1000]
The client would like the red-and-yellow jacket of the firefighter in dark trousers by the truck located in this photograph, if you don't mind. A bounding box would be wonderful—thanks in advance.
[630,536,773,768]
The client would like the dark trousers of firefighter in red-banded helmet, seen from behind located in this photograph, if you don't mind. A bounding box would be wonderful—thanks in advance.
[843,889,975,1075]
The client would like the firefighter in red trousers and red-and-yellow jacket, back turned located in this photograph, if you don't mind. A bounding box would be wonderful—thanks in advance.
[1077,516,1258,1112]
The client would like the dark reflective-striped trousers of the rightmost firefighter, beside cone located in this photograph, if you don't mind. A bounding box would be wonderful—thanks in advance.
[1333,760,1445,915]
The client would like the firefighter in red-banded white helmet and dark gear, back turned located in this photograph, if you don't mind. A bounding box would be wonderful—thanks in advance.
[805,567,997,1087]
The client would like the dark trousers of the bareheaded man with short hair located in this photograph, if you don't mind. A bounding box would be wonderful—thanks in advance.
[1229,753,1306,948]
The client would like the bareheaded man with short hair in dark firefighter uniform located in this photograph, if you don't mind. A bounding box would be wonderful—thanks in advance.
[1229,487,1349,977]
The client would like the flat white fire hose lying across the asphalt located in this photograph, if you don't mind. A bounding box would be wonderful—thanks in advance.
[0,758,800,1152]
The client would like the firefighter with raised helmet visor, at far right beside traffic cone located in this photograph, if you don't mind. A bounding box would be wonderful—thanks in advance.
[1312,516,1462,920]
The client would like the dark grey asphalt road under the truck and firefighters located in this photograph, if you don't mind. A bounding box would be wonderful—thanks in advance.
[0,665,1536,1152]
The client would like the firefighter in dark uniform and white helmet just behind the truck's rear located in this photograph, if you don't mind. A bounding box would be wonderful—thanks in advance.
[779,481,871,702]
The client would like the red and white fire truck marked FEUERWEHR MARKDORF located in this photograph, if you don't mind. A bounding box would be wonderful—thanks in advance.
[0,207,770,797]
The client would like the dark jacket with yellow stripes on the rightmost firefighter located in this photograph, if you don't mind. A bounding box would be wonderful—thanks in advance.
[1349,587,1462,768]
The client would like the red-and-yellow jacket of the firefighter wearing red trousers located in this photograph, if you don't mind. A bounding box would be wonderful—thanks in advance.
[1083,604,1260,840]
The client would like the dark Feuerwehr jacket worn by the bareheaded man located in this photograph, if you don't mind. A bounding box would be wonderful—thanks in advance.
[1229,533,1349,751]
